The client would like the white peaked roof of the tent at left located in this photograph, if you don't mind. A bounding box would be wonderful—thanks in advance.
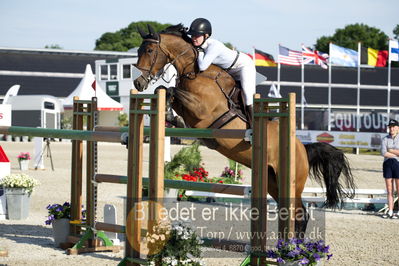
[63,64,123,111]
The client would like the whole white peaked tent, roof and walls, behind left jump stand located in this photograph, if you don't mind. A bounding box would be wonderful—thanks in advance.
[63,65,123,126]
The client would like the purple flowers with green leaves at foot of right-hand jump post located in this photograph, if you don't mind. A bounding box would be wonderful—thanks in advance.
[266,238,332,265]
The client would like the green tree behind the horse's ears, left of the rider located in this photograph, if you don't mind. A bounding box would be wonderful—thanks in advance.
[94,21,171,51]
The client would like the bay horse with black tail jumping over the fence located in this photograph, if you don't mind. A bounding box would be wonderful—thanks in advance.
[134,24,355,233]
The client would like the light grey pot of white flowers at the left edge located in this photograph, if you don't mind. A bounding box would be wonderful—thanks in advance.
[0,173,39,220]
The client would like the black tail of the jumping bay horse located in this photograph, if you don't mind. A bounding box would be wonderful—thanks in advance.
[305,142,356,208]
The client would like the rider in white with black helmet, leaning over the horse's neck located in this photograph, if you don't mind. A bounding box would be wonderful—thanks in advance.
[187,18,256,128]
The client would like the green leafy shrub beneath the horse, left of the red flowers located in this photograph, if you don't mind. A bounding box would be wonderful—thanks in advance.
[165,141,202,179]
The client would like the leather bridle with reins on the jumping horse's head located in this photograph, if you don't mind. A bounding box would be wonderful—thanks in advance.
[135,35,197,84]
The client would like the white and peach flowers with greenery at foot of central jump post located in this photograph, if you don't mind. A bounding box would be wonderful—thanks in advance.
[144,220,203,266]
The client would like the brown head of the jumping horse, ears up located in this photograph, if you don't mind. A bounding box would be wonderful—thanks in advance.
[134,25,168,91]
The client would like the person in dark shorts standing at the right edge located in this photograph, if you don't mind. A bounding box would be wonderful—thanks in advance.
[381,119,399,219]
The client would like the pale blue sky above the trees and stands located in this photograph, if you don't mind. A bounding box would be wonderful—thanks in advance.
[0,0,399,56]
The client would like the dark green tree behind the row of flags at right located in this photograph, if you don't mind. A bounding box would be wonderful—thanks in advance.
[315,23,390,53]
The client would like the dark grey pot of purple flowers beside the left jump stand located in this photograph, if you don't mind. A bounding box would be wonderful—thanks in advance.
[45,202,71,247]
